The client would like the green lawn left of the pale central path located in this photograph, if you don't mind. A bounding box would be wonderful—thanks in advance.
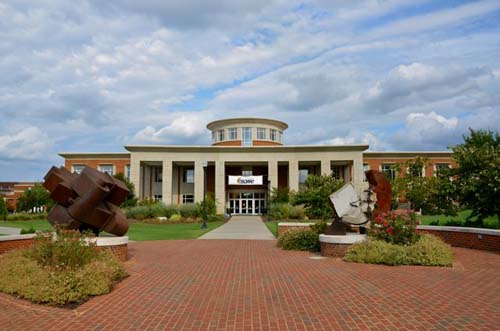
[0,221,223,241]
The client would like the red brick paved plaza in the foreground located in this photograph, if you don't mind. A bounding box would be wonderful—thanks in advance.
[0,240,500,330]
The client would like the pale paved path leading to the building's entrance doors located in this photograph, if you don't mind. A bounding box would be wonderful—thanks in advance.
[199,216,276,240]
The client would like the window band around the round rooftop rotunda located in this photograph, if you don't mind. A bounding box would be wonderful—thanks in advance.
[212,128,283,146]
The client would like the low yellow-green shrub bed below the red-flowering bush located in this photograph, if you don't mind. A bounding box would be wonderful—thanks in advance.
[344,234,453,266]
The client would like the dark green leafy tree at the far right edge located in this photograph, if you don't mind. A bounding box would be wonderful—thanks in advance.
[452,129,500,223]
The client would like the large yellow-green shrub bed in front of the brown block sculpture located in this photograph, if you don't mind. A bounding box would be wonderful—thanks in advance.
[0,230,126,305]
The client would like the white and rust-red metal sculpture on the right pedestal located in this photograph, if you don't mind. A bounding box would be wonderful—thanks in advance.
[326,170,392,235]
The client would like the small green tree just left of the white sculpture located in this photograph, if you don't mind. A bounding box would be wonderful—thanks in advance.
[292,175,344,220]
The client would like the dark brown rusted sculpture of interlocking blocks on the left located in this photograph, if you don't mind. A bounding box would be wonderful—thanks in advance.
[43,167,129,236]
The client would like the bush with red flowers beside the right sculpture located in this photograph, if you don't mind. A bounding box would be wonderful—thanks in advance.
[369,211,419,245]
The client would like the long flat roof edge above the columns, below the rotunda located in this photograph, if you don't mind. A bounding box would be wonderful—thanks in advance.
[124,144,368,153]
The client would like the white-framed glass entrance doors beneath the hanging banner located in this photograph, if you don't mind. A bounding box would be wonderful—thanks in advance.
[227,191,266,215]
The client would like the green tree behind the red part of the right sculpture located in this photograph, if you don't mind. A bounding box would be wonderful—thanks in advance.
[393,157,456,215]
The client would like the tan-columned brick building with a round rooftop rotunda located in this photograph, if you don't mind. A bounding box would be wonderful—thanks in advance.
[59,118,453,214]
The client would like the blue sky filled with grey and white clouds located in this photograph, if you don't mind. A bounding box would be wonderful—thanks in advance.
[0,0,500,181]
